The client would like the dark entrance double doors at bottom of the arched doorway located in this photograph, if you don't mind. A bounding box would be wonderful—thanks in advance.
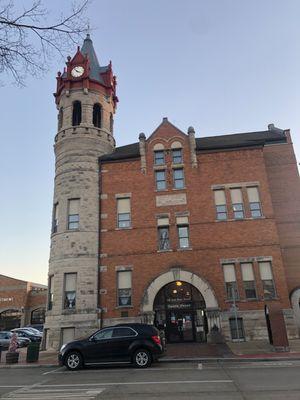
[166,310,195,342]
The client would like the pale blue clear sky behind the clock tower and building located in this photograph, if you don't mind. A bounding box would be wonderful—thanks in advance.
[0,0,300,284]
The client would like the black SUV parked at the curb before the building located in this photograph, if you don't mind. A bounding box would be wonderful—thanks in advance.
[58,324,164,370]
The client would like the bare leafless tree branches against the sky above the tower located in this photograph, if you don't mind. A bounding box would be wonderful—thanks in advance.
[0,0,89,86]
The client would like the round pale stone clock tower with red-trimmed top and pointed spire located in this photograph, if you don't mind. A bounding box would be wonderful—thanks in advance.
[45,35,118,349]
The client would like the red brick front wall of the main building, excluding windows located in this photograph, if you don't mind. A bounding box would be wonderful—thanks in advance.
[101,124,289,318]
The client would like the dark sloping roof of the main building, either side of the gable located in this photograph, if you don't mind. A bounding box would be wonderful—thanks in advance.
[99,128,287,161]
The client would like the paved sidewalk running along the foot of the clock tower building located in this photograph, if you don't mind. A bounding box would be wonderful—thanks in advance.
[0,339,300,369]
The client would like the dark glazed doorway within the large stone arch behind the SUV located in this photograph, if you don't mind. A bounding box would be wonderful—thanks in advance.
[153,280,208,343]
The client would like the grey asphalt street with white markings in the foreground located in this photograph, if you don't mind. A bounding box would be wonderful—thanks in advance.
[0,361,300,400]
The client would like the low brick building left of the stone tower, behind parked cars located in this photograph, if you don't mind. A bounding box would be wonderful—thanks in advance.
[0,275,47,330]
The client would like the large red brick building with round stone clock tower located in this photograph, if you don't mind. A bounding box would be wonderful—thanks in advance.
[46,36,300,348]
